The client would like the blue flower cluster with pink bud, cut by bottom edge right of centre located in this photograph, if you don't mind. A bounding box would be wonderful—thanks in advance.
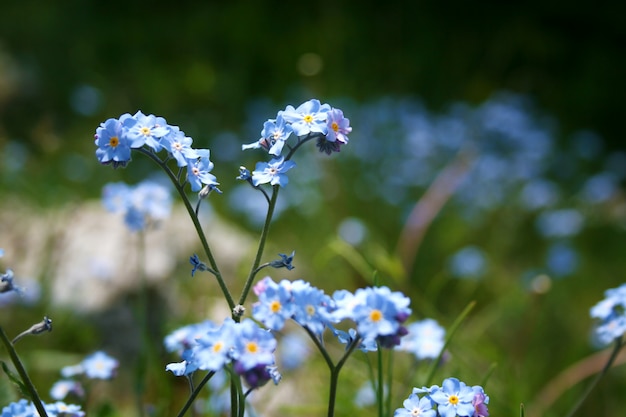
[394,378,489,417]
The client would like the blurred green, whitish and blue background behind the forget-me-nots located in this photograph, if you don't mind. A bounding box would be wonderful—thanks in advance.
[0,0,626,416]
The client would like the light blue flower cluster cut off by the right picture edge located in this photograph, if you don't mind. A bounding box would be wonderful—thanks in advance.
[590,284,626,344]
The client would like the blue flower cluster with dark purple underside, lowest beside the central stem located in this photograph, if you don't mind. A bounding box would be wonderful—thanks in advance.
[165,319,280,388]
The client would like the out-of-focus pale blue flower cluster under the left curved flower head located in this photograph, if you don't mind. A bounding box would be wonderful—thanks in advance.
[102,180,172,231]
